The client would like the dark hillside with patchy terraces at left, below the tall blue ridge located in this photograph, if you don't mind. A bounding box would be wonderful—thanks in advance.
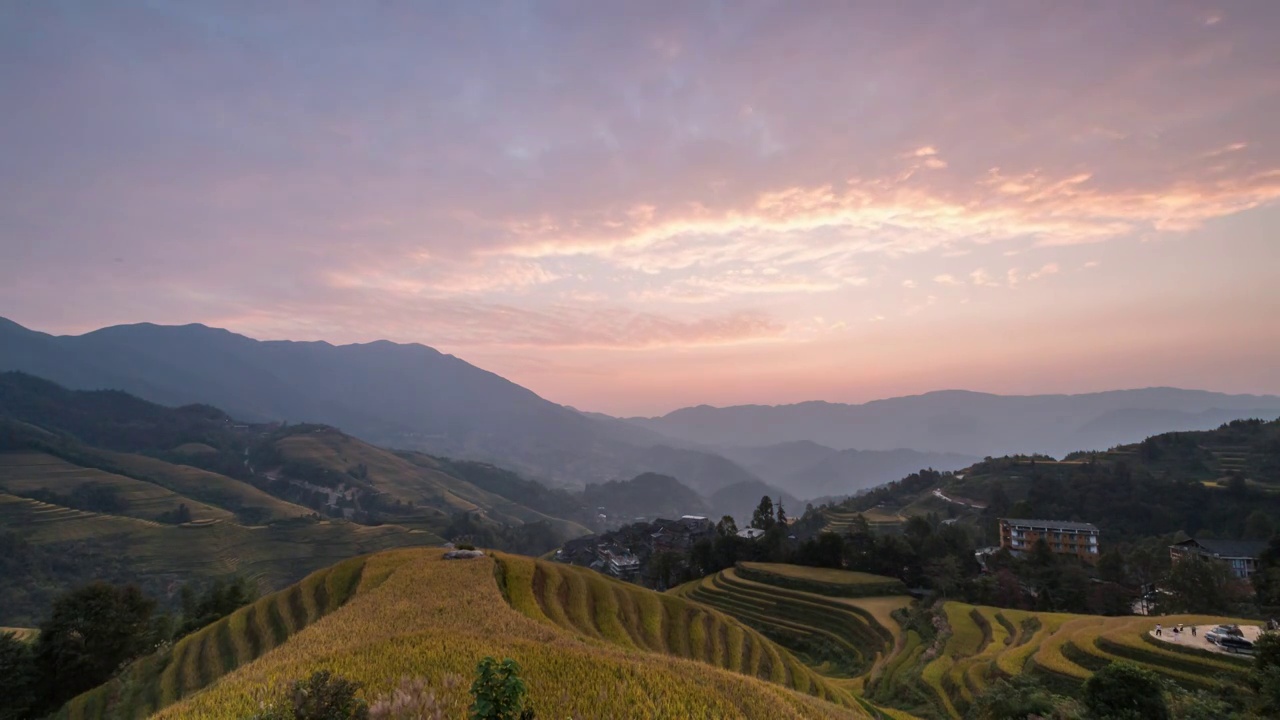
[0,373,609,625]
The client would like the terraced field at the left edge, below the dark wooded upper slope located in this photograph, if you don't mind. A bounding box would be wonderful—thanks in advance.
[0,452,234,520]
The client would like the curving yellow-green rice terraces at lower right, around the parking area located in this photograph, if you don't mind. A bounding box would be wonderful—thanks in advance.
[669,566,1264,719]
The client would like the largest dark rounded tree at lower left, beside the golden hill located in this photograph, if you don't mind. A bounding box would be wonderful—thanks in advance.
[36,583,156,710]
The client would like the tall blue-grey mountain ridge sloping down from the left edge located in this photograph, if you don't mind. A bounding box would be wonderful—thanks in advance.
[0,319,758,493]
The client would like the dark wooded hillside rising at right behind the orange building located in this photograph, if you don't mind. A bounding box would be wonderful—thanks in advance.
[819,420,1280,543]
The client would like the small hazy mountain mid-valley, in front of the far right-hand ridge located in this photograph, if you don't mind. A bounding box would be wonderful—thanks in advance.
[721,441,979,498]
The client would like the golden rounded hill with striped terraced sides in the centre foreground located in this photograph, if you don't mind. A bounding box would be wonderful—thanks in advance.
[59,550,873,719]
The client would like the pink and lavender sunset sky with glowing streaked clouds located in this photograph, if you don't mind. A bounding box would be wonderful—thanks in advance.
[0,0,1280,415]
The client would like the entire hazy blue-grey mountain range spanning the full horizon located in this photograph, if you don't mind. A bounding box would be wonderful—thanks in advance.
[0,313,1280,504]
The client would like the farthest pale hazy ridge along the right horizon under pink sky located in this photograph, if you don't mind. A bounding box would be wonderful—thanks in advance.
[628,388,1280,457]
